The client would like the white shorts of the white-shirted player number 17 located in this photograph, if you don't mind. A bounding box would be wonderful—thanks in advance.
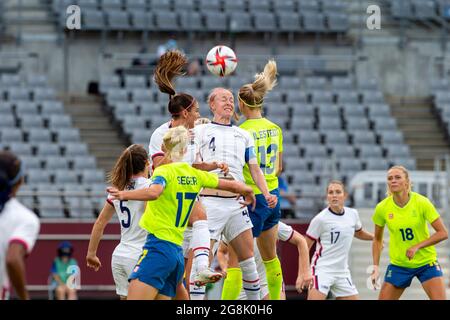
[313,272,358,298]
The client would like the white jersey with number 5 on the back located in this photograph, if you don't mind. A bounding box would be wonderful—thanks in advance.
[107,177,151,260]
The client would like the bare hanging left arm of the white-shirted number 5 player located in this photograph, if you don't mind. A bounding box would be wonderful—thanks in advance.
[86,202,115,271]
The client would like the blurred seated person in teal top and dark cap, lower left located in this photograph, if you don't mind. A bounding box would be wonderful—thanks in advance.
[51,241,78,300]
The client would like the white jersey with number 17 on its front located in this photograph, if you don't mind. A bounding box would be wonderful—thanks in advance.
[306,207,362,275]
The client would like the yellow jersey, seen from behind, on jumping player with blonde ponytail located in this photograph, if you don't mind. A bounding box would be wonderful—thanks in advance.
[239,118,283,194]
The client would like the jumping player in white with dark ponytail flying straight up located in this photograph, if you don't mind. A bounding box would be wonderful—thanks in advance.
[149,51,228,299]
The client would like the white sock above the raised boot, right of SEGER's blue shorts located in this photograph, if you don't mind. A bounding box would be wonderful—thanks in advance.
[191,220,210,273]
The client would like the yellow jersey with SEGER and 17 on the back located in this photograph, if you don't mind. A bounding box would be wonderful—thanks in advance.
[139,162,219,246]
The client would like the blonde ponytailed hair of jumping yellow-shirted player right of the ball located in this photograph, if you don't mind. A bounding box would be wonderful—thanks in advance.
[238,60,277,108]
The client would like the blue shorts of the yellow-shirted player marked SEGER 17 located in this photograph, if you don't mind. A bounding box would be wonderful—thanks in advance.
[128,234,184,297]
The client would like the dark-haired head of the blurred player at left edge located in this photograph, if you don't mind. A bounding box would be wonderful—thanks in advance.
[0,151,22,212]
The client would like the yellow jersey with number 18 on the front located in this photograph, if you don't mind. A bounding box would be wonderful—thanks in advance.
[372,192,439,268]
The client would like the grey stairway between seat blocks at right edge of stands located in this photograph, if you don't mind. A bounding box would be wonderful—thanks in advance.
[387,97,450,170]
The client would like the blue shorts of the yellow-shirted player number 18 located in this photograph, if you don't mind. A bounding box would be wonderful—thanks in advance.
[384,261,442,288]
